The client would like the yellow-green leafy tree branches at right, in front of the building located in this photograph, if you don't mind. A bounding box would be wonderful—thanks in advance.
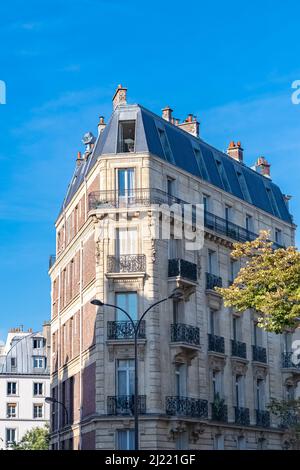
[215,230,300,333]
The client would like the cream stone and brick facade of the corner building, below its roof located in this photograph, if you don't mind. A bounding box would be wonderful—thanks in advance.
[50,88,300,450]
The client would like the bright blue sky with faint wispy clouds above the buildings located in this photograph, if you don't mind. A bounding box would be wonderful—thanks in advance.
[0,0,300,338]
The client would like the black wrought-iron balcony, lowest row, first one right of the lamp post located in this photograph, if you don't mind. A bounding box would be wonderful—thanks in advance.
[166,397,208,419]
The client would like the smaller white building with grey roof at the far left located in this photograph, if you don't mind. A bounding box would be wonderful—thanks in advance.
[0,323,50,449]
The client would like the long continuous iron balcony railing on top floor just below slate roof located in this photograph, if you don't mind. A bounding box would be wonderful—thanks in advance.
[88,188,281,248]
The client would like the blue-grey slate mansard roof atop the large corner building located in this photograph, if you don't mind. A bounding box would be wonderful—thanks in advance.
[62,105,292,223]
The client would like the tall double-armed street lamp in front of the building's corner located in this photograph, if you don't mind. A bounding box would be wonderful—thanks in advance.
[91,289,182,450]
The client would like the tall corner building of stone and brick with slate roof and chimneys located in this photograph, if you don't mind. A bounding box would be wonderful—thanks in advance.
[49,86,300,450]
